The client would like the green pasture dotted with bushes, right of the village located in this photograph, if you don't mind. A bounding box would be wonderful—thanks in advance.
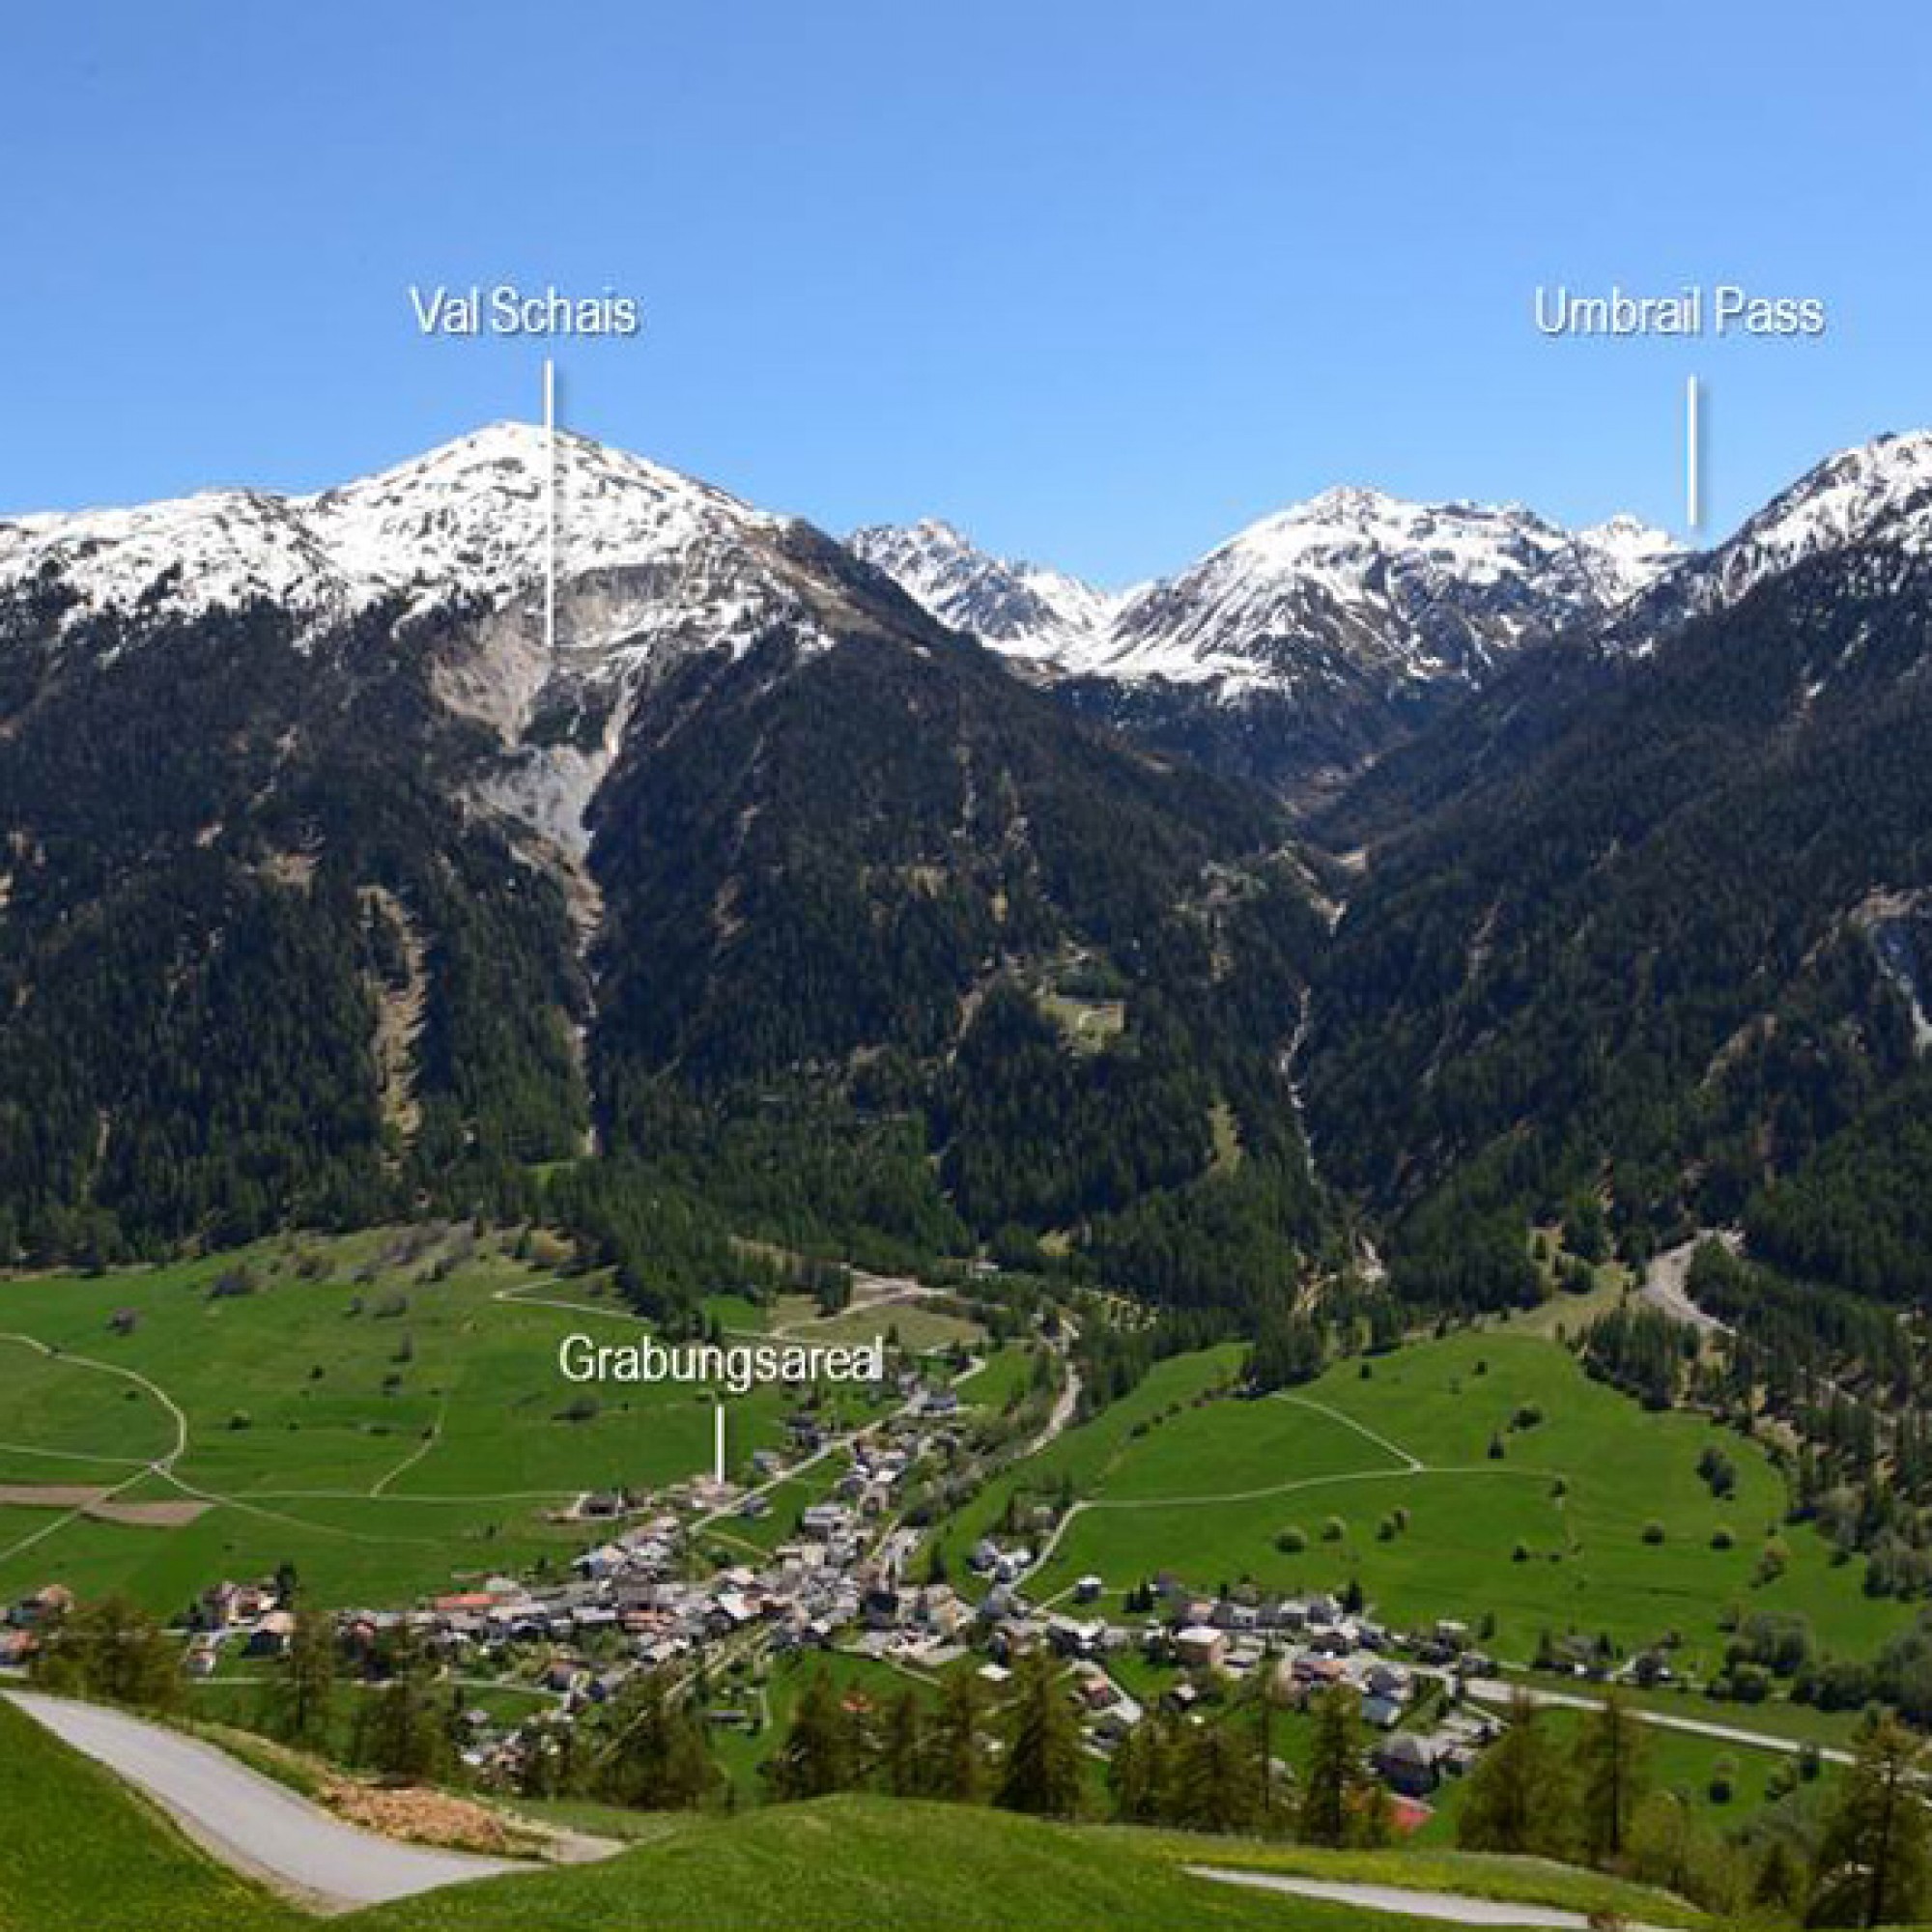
[1005,1329,1913,1669]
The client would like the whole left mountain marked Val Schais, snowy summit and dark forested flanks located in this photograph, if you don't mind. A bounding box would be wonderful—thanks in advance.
[0,425,1323,1306]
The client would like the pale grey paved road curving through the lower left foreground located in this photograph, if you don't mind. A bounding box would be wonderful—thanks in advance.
[4,1690,529,1909]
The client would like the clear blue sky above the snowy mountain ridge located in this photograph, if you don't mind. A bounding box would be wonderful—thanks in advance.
[0,0,1932,582]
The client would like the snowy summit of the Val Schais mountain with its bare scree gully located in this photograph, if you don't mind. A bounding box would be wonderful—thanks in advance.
[0,435,935,873]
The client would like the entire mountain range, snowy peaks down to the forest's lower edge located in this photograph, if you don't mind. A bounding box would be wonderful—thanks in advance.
[0,425,1932,1320]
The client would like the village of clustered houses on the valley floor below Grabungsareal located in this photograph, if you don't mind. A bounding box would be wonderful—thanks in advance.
[0,1352,1522,1828]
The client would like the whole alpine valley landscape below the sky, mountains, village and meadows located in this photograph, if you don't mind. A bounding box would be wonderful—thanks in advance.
[11,425,1932,1932]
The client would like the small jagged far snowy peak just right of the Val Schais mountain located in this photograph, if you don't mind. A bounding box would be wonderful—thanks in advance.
[846,518,1121,670]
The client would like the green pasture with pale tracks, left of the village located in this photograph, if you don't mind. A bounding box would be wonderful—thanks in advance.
[0,1231,912,1611]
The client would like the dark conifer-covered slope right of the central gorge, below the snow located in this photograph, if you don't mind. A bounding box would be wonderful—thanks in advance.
[1308,541,1932,1300]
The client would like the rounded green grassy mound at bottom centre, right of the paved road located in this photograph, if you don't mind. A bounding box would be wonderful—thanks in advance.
[342,1797,1694,1932]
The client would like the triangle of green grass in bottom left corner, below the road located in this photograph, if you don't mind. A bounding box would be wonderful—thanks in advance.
[0,1702,303,1932]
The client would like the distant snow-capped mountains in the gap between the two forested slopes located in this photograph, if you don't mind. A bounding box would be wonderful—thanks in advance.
[852,489,1683,790]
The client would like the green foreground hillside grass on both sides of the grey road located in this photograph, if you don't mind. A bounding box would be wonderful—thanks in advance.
[0,1704,1698,1932]
